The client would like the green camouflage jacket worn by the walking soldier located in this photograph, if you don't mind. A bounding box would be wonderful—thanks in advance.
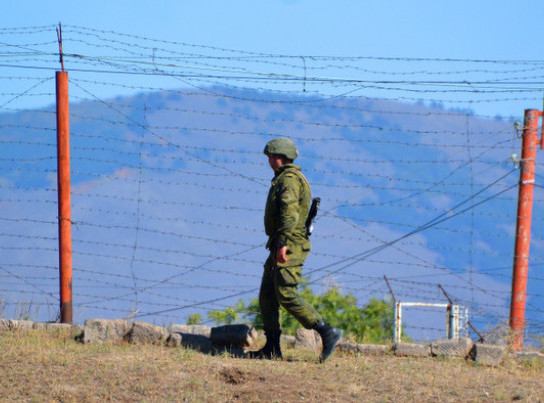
[264,164,312,258]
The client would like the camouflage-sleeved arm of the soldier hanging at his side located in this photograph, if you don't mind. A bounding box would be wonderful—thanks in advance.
[276,174,301,247]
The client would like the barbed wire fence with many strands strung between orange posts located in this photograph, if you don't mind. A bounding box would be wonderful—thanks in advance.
[0,25,544,339]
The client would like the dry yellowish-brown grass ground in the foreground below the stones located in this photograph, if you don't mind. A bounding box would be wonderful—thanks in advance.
[0,331,544,402]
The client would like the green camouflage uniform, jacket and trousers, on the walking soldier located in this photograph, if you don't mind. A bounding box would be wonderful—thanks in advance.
[259,164,322,333]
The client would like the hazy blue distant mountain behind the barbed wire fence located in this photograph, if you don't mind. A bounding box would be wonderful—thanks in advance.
[0,87,544,344]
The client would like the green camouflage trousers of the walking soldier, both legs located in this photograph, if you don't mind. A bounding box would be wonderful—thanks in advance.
[259,254,322,332]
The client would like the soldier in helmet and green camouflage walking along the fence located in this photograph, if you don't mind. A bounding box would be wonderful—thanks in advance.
[250,138,342,361]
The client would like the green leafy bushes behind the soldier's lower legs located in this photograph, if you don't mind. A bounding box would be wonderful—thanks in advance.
[193,284,394,344]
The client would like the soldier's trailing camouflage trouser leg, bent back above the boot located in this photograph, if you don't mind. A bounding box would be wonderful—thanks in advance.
[274,266,322,329]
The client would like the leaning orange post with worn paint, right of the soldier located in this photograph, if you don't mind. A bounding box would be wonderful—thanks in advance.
[510,109,541,351]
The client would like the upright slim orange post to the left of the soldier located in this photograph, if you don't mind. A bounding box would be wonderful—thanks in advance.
[56,71,72,323]
